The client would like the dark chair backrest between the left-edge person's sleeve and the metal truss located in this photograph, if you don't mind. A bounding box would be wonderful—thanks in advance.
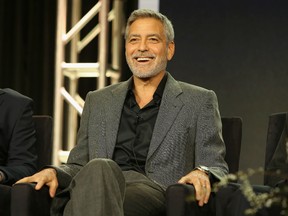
[33,115,53,169]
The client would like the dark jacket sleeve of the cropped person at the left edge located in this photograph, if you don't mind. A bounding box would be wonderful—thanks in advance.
[0,99,37,184]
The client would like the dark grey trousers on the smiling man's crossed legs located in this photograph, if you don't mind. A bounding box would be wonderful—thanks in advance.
[52,159,165,216]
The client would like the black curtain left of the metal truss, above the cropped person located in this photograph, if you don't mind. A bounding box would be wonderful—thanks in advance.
[0,0,56,115]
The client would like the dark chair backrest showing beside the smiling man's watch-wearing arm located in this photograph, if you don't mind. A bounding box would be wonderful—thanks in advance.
[221,116,242,173]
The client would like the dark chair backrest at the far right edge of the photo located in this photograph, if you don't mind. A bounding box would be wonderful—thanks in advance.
[264,112,288,186]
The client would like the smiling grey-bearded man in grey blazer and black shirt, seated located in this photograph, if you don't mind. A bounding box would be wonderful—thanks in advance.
[19,9,228,216]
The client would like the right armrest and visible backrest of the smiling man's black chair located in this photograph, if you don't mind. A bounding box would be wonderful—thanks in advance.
[166,117,242,216]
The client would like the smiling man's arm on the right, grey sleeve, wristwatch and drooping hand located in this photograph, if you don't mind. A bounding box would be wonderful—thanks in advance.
[178,91,228,206]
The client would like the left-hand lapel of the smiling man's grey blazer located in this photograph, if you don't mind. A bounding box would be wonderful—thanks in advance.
[104,79,130,158]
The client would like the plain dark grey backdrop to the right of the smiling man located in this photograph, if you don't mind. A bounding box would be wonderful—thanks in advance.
[160,0,288,182]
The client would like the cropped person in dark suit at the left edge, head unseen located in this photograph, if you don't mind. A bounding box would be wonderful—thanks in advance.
[0,89,37,216]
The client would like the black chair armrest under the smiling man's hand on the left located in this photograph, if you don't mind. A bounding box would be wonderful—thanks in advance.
[11,183,52,216]
